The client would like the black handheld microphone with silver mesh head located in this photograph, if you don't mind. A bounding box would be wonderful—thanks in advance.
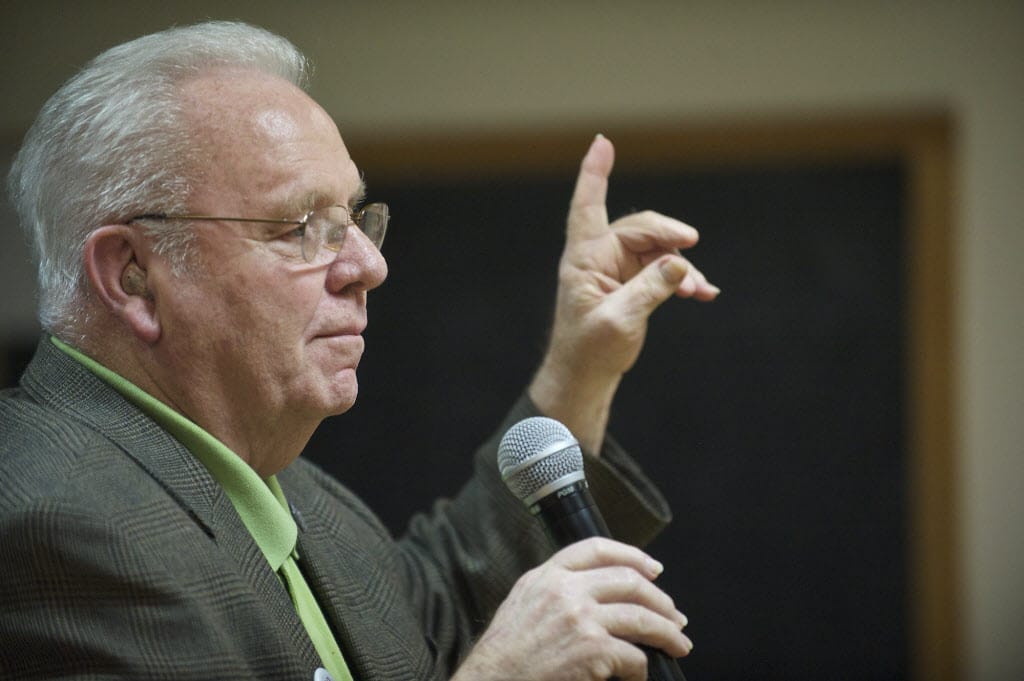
[498,416,686,681]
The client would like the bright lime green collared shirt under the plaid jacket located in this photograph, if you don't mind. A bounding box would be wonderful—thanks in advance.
[50,336,351,680]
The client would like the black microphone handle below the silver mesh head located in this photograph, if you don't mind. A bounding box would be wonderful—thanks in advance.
[529,479,686,681]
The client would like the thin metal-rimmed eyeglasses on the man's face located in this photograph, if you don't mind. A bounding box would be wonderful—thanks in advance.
[129,204,391,265]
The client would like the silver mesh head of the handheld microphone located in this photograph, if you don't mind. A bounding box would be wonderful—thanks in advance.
[498,416,583,501]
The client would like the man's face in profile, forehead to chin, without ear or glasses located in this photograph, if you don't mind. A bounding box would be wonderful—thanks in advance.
[150,71,387,434]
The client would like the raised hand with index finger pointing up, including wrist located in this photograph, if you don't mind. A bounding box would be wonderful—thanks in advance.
[529,135,719,454]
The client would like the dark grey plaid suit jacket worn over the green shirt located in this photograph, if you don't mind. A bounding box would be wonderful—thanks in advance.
[0,339,668,681]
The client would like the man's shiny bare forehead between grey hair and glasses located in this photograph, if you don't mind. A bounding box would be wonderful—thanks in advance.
[181,69,361,211]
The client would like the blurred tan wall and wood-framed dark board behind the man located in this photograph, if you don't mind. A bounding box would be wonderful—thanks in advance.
[0,0,1024,681]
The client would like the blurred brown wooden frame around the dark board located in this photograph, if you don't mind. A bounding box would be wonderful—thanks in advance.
[347,112,964,681]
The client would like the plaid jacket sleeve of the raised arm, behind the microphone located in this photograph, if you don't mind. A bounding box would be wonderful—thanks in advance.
[398,396,671,674]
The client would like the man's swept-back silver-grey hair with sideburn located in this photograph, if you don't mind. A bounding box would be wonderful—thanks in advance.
[8,22,309,336]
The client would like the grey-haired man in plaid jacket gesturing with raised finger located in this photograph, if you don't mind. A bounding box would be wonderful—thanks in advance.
[0,23,718,681]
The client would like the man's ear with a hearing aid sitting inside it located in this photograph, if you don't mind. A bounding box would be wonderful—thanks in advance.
[83,224,161,344]
